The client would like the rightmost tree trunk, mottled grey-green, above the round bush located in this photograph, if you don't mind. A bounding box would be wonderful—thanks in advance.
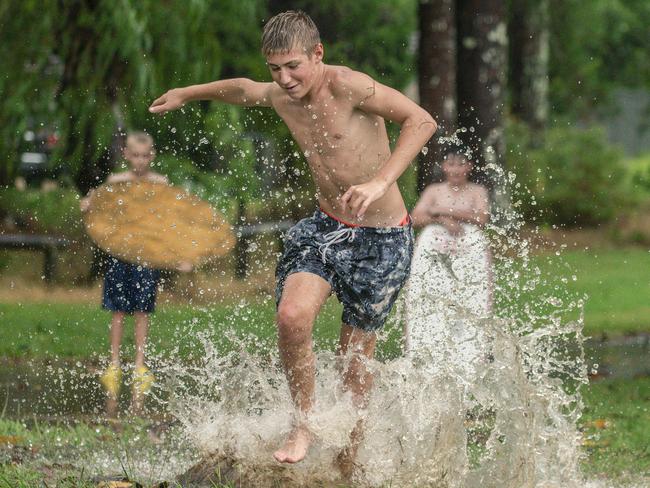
[508,0,549,130]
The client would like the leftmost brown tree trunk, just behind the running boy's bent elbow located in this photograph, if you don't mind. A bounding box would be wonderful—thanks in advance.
[418,0,456,192]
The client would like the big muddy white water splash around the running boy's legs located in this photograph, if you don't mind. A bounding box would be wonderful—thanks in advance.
[144,155,586,488]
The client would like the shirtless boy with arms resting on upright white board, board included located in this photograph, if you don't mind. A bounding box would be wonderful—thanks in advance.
[404,152,492,367]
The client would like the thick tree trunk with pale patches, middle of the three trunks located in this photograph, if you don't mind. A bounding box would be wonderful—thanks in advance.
[457,0,508,189]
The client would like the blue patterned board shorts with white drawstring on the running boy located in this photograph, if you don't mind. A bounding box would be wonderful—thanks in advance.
[275,210,413,331]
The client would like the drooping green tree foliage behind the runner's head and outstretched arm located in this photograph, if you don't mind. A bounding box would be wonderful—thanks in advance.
[0,0,415,197]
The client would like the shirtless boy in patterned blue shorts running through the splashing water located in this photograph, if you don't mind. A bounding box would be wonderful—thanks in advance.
[149,11,436,463]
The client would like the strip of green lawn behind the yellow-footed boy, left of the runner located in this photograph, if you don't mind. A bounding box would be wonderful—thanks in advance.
[0,302,327,358]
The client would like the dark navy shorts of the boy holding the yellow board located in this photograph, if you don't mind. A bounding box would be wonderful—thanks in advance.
[102,256,160,313]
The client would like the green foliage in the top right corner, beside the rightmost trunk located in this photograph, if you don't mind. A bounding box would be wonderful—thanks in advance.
[550,0,650,116]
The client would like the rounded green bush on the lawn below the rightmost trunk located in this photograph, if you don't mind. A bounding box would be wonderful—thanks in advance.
[507,119,627,227]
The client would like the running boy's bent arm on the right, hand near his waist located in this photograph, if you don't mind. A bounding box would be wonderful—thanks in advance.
[341,71,438,217]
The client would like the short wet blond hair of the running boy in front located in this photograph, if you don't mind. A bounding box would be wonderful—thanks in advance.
[262,10,320,56]
